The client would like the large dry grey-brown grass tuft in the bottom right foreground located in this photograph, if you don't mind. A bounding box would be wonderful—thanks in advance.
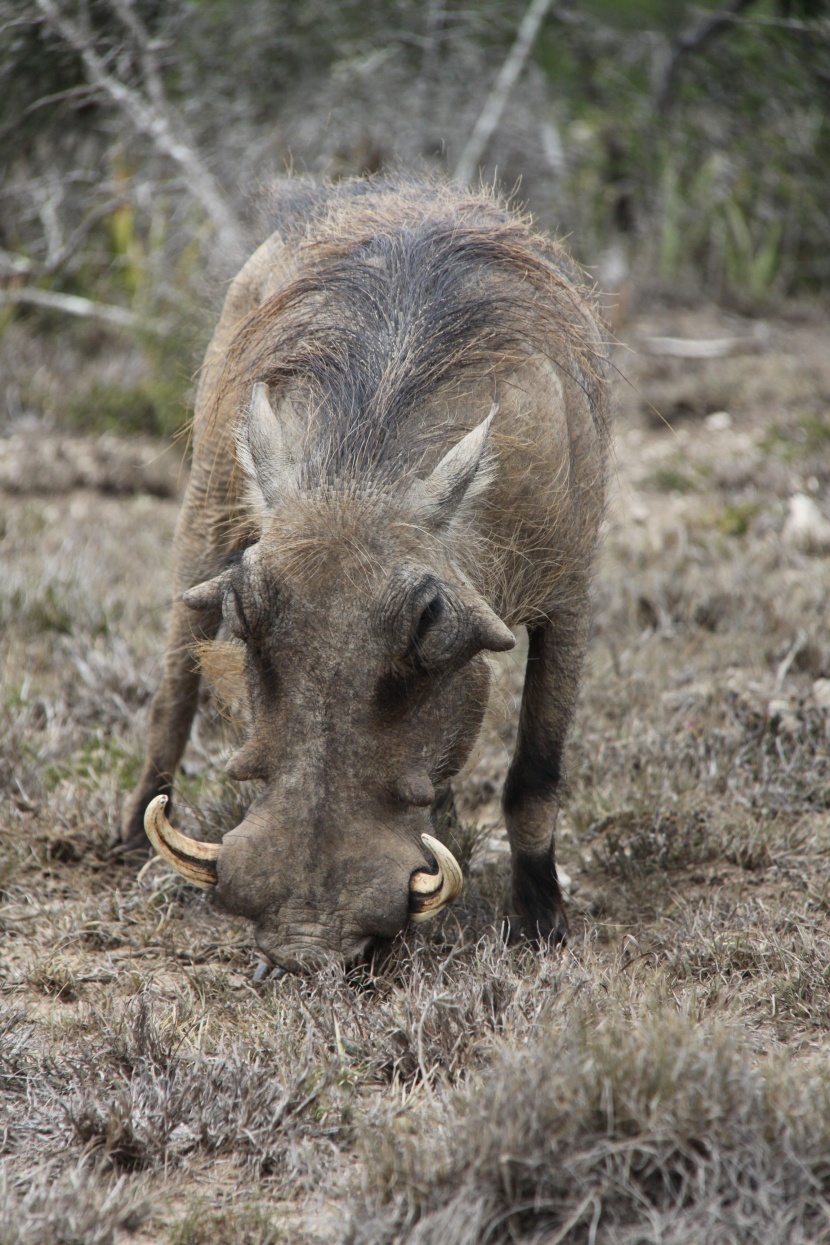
[353,1000,830,1245]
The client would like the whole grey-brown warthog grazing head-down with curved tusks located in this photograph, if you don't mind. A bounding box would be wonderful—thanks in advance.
[122,178,607,969]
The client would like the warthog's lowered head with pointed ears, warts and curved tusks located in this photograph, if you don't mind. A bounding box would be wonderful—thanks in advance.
[146,385,514,969]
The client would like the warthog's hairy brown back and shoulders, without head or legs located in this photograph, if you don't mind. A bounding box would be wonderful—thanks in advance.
[194,181,607,625]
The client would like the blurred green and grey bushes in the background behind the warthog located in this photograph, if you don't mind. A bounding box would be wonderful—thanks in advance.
[0,0,830,433]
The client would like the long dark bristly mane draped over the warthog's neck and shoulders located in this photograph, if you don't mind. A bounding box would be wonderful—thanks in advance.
[223,182,600,487]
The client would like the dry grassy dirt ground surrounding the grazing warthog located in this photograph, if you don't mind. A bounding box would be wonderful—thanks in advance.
[0,300,830,1245]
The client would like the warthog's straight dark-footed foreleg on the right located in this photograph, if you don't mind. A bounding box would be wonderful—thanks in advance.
[503,604,587,942]
